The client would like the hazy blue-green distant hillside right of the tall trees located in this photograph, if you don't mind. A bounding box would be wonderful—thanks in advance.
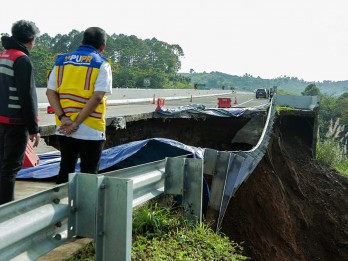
[180,72,348,96]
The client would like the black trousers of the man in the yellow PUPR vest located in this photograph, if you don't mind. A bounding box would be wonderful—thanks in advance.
[56,136,105,184]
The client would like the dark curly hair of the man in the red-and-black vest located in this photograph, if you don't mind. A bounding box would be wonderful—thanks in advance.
[11,20,40,44]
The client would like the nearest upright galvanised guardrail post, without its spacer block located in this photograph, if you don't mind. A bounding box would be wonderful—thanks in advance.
[96,176,133,261]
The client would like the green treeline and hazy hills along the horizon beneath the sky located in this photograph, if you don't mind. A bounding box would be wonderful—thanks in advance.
[4,29,348,93]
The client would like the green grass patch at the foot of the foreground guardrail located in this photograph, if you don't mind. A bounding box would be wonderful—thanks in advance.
[69,203,248,261]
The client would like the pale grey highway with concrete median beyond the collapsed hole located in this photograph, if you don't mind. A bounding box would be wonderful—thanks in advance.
[38,88,268,126]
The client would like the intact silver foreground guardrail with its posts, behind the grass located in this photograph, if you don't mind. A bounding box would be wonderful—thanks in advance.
[0,157,203,261]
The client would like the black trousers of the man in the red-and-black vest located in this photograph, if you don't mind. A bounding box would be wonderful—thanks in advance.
[0,123,28,205]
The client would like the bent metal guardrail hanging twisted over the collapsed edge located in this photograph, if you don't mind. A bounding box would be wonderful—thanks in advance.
[204,95,276,231]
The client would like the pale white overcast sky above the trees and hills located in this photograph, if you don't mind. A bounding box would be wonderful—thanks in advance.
[0,0,348,81]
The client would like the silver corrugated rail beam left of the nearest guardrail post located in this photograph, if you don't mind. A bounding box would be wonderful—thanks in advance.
[0,185,68,260]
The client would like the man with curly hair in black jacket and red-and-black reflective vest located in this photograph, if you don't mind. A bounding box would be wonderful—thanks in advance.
[0,20,40,205]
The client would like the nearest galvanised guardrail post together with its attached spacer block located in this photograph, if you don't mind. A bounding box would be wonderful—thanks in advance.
[68,173,133,261]
